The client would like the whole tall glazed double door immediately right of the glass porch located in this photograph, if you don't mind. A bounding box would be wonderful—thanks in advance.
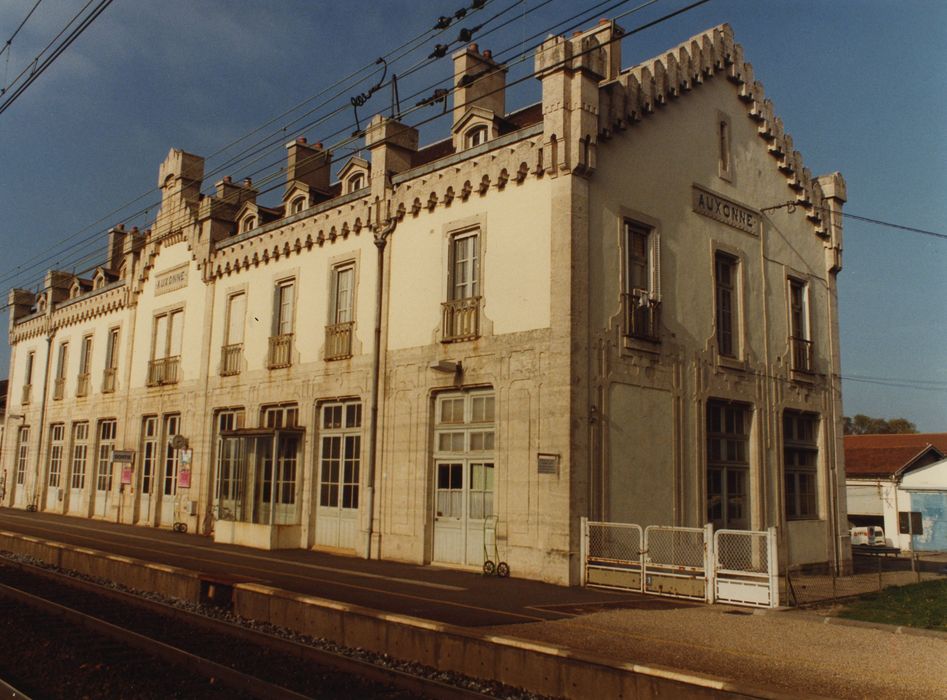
[316,401,362,549]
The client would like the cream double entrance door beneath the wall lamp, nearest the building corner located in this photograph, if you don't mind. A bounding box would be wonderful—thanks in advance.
[433,391,495,566]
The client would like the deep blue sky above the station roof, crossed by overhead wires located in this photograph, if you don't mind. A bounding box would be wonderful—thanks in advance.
[0,0,947,432]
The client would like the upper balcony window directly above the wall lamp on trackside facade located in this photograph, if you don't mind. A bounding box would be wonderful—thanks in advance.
[442,230,481,343]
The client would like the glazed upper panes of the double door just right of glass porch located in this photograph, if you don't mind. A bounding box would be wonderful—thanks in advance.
[319,401,362,509]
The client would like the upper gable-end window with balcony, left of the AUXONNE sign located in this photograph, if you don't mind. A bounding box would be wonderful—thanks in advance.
[622,221,660,342]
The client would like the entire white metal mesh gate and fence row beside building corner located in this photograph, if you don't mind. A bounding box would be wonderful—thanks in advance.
[582,518,779,607]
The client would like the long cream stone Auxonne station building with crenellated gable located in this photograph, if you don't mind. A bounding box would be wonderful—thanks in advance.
[0,21,850,584]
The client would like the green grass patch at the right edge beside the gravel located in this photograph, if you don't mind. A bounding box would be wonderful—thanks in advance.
[838,579,947,632]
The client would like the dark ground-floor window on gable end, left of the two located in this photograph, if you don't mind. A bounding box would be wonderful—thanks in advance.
[707,400,750,530]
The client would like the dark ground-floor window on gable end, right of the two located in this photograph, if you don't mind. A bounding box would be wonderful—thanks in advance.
[783,411,819,520]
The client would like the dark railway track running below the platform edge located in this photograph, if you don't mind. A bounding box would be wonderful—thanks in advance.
[0,560,516,700]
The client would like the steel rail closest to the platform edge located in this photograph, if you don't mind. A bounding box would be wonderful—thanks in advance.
[0,558,500,700]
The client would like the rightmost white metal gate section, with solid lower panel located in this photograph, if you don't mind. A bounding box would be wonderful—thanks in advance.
[714,527,779,608]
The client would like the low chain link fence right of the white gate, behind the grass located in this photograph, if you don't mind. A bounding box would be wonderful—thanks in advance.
[782,547,947,606]
